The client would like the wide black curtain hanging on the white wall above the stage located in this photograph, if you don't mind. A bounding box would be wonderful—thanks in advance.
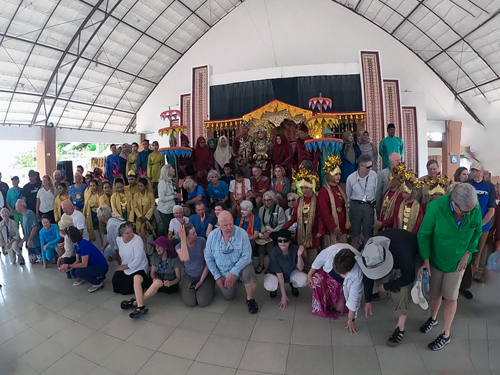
[210,74,363,120]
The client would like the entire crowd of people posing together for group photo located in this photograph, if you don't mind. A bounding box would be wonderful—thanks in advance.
[0,123,500,350]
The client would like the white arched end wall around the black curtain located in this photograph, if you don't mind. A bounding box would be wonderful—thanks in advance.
[137,0,500,170]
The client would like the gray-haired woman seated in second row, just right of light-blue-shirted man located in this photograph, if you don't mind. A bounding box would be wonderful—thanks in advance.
[255,190,286,273]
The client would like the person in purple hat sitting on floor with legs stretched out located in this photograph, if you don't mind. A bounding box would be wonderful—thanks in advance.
[120,236,182,318]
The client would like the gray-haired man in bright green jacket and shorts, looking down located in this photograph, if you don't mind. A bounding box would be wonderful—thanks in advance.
[418,184,483,350]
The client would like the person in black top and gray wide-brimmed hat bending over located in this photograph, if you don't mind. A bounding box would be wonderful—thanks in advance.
[358,229,418,347]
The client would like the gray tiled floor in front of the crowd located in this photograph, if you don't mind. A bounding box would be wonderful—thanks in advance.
[0,256,500,375]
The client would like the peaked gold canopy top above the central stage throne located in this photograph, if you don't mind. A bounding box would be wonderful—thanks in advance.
[243,99,312,127]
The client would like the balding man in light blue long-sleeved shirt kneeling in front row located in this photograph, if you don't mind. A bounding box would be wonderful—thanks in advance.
[205,211,259,314]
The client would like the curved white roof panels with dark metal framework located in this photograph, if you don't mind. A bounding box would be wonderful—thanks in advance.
[0,0,500,132]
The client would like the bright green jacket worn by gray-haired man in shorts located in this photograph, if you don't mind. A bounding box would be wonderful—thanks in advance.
[418,194,483,272]
